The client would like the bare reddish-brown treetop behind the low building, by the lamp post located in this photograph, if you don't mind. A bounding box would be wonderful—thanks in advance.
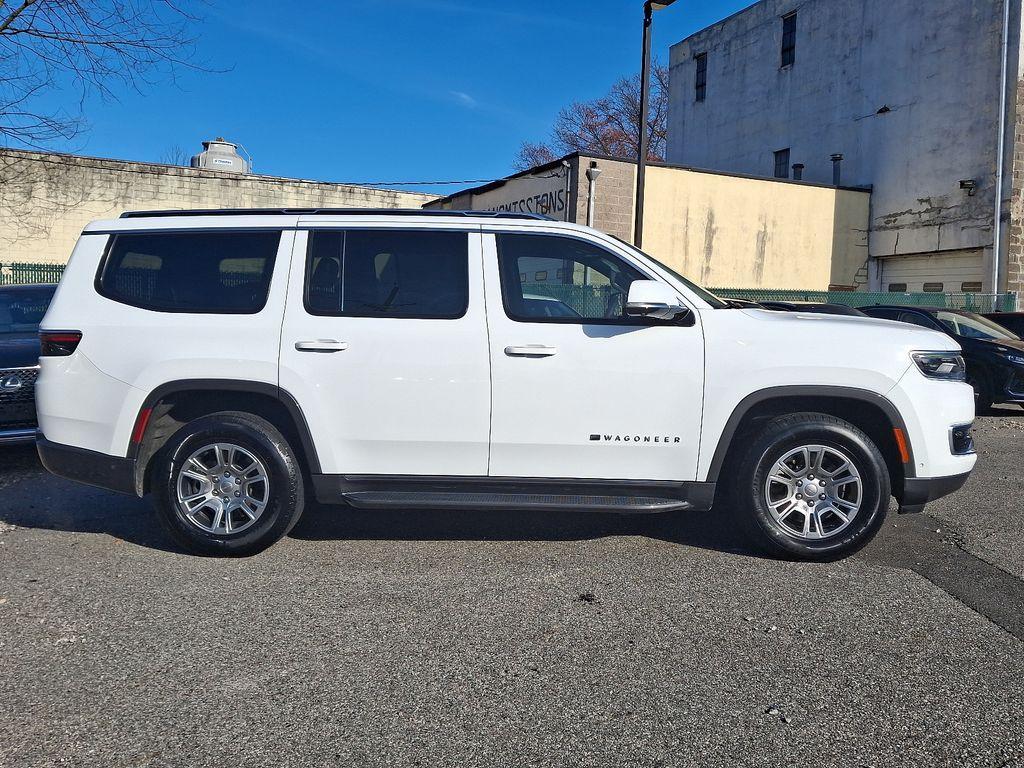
[514,62,669,170]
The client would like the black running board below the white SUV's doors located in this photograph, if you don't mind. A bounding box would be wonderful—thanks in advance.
[312,475,715,514]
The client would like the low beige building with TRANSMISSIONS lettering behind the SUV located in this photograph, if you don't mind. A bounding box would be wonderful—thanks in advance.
[426,154,870,291]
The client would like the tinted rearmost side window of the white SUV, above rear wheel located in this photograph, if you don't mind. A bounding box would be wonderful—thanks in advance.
[97,231,281,314]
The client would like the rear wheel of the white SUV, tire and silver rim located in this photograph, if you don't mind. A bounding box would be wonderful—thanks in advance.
[154,412,303,556]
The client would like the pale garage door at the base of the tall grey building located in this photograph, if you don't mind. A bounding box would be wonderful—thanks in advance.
[881,250,985,293]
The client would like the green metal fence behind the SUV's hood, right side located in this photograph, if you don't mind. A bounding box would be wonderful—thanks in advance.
[709,288,1017,312]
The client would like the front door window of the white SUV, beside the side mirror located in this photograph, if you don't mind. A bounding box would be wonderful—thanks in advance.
[497,234,647,325]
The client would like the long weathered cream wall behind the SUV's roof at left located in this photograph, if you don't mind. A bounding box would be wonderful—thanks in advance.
[0,150,433,263]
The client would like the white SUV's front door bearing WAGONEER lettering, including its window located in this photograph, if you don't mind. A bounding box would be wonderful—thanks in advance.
[483,228,703,480]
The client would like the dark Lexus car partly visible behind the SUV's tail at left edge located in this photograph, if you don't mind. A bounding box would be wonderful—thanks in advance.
[0,286,56,444]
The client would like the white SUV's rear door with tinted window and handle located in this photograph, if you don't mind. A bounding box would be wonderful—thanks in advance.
[281,228,490,475]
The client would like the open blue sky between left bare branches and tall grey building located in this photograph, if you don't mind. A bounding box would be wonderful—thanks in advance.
[34,0,751,191]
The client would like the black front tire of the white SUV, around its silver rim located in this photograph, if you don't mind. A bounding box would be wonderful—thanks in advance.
[733,413,891,560]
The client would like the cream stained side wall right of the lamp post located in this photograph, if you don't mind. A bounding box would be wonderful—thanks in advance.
[643,160,869,291]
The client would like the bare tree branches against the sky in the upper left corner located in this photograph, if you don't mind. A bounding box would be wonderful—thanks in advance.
[0,0,212,146]
